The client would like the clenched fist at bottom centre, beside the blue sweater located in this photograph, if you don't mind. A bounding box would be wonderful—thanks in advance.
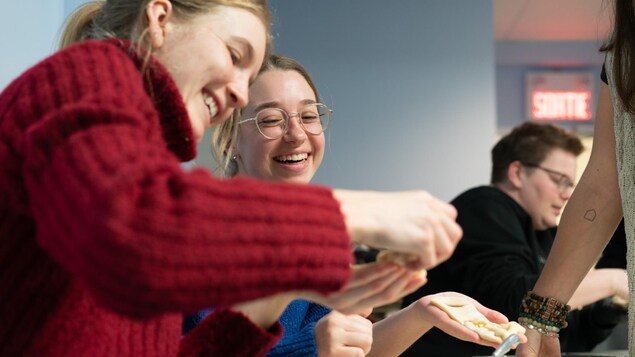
[315,311,373,357]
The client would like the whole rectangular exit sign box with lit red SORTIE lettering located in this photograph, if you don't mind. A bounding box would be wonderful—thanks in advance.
[525,71,594,121]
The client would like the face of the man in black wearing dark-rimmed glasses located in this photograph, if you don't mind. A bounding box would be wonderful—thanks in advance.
[516,149,576,230]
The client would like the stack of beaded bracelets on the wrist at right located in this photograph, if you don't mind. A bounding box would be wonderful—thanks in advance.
[518,291,571,337]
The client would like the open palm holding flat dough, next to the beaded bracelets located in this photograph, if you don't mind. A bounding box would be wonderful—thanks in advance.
[408,292,527,348]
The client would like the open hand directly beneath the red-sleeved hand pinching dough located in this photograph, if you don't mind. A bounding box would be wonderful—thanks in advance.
[300,263,427,314]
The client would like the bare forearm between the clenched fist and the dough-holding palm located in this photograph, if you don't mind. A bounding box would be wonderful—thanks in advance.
[367,305,434,356]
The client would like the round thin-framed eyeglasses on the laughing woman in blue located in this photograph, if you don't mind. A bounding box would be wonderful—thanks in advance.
[238,103,333,139]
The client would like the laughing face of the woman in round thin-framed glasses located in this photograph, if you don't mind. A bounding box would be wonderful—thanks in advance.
[236,70,325,183]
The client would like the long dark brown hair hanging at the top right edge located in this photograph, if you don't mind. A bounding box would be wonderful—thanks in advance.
[600,0,635,114]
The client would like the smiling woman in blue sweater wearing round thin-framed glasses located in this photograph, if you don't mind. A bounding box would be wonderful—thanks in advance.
[193,55,524,356]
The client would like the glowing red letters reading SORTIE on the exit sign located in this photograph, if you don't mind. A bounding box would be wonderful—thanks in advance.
[531,91,592,120]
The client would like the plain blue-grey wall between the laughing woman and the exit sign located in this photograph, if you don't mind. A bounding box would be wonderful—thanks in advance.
[198,0,496,200]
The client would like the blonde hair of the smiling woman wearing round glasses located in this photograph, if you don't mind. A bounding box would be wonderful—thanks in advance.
[212,54,320,177]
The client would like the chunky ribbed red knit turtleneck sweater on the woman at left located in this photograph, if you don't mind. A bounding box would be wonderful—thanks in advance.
[0,40,351,356]
